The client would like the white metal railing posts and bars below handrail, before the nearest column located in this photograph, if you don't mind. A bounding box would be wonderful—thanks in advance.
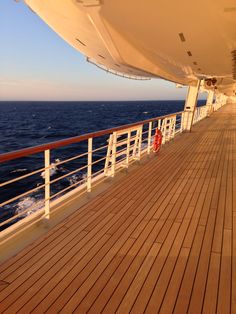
[0,112,182,232]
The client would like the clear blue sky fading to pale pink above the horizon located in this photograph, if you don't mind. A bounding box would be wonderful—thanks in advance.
[0,0,205,100]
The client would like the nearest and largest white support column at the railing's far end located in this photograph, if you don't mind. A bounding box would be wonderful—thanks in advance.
[183,80,200,132]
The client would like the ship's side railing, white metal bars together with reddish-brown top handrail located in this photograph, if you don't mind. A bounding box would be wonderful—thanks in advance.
[0,102,223,237]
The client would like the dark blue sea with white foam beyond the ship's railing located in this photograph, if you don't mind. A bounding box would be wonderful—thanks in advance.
[0,101,205,228]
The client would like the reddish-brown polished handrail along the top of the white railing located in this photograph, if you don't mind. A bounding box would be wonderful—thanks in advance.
[0,111,183,162]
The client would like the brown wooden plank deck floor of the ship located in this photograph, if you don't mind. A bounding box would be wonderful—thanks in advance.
[0,104,236,314]
